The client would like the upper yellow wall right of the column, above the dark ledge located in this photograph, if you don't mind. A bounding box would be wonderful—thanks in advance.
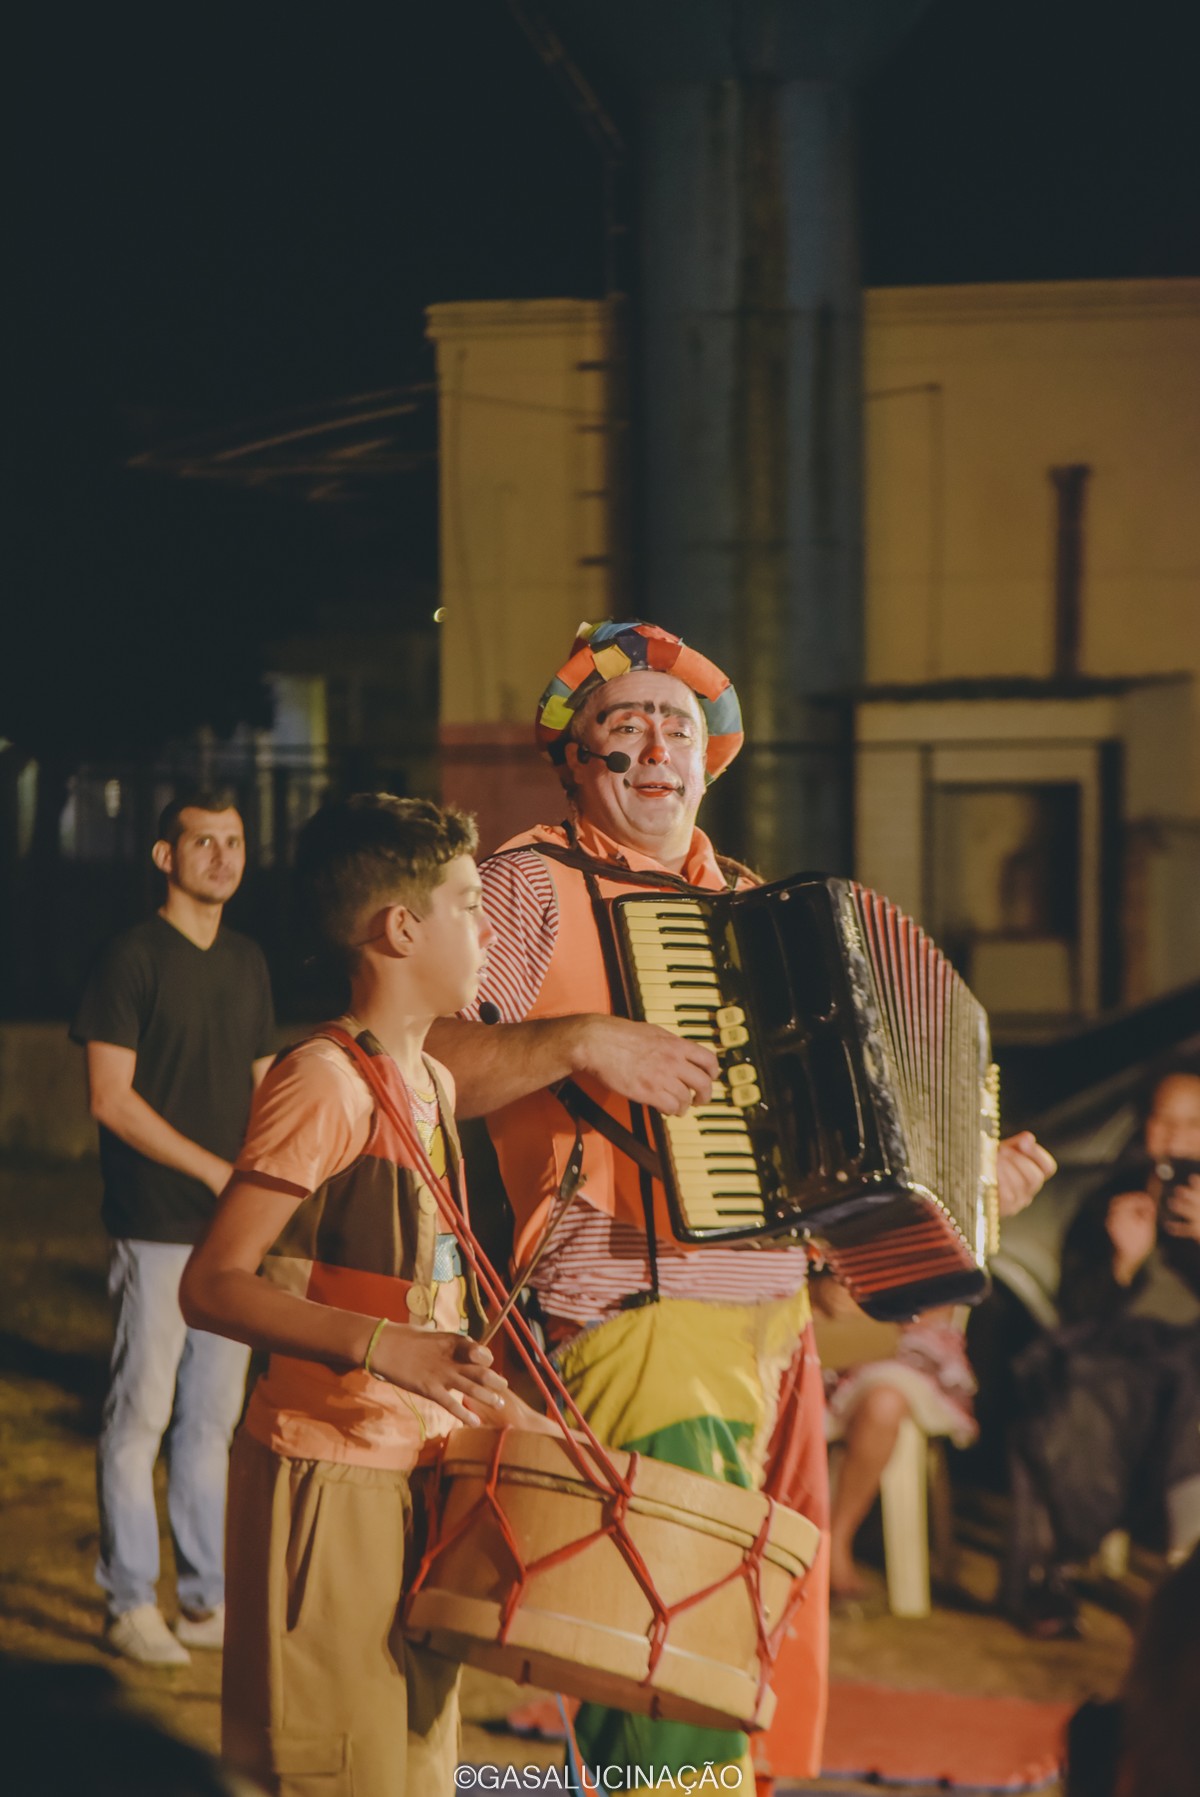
[866,280,1200,801]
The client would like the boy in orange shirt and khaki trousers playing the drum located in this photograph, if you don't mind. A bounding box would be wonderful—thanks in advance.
[180,794,553,1797]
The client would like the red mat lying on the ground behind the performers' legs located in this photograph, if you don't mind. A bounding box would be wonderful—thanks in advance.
[508,1684,1074,1792]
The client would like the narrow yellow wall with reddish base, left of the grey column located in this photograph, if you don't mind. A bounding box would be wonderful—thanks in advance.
[428,300,613,848]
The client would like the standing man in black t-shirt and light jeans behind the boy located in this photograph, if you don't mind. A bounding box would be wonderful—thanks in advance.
[70,792,275,1666]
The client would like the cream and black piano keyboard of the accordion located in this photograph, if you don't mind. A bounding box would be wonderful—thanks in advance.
[622,899,763,1231]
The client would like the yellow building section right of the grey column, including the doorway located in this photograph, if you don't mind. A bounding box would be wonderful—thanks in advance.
[855,280,1200,1030]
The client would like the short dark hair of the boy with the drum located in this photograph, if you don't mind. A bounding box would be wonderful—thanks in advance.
[296,792,478,956]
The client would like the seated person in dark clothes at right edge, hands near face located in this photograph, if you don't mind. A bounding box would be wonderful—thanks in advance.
[1004,1067,1200,1639]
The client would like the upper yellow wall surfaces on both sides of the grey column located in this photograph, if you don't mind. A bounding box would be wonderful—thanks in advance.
[429,280,1200,801]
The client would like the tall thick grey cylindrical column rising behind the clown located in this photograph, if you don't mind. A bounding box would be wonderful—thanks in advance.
[555,0,925,875]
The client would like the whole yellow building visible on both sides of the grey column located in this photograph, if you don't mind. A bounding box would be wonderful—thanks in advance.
[429,280,1200,1035]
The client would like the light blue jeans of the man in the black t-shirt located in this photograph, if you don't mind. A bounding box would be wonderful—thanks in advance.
[95,1240,250,1616]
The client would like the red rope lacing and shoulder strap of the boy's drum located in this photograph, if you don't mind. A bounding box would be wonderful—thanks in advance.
[318,1024,807,1707]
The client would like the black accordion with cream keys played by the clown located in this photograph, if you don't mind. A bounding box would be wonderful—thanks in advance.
[611,877,999,1321]
